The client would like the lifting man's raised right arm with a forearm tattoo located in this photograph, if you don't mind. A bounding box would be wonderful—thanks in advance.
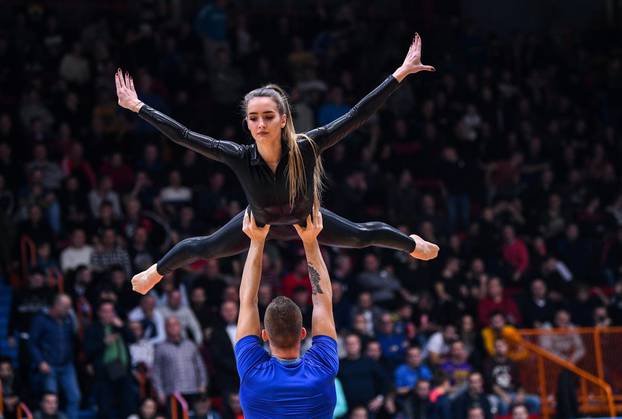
[294,208,337,339]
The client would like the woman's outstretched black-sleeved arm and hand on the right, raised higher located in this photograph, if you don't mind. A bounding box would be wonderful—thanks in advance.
[308,34,436,151]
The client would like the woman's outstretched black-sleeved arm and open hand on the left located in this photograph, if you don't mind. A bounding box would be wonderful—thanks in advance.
[115,69,244,163]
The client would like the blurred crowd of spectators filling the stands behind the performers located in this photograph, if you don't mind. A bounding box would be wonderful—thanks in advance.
[0,0,622,419]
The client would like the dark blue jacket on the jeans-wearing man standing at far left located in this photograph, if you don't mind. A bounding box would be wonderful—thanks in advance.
[29,312,75,368]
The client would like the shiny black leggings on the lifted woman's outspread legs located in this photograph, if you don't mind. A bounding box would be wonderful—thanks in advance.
[157,208,415,275]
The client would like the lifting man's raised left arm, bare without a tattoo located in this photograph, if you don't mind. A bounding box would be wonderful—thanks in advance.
[235,210,270,342]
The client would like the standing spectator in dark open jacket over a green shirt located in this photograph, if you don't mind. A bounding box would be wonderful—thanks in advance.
[85,302,136,419]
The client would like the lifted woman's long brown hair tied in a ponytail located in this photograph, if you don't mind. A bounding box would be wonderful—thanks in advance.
[242,84,324,208]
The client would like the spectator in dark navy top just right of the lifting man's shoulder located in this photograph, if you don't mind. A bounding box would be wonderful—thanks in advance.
[338,334,388,412]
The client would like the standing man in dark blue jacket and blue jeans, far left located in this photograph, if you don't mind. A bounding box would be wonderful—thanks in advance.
[30,294,80,419]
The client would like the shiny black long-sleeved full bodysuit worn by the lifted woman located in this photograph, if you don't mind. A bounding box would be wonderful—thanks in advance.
[139,76,415,274]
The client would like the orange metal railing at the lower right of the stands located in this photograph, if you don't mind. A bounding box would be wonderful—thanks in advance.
[519,327,622,419]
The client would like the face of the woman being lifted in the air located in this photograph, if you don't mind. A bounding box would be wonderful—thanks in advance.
[246,97,286,143]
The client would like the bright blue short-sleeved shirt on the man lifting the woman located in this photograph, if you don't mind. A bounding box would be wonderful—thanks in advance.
[235,336,339,419]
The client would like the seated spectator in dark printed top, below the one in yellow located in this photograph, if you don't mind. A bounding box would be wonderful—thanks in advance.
[485,338,540,416]
